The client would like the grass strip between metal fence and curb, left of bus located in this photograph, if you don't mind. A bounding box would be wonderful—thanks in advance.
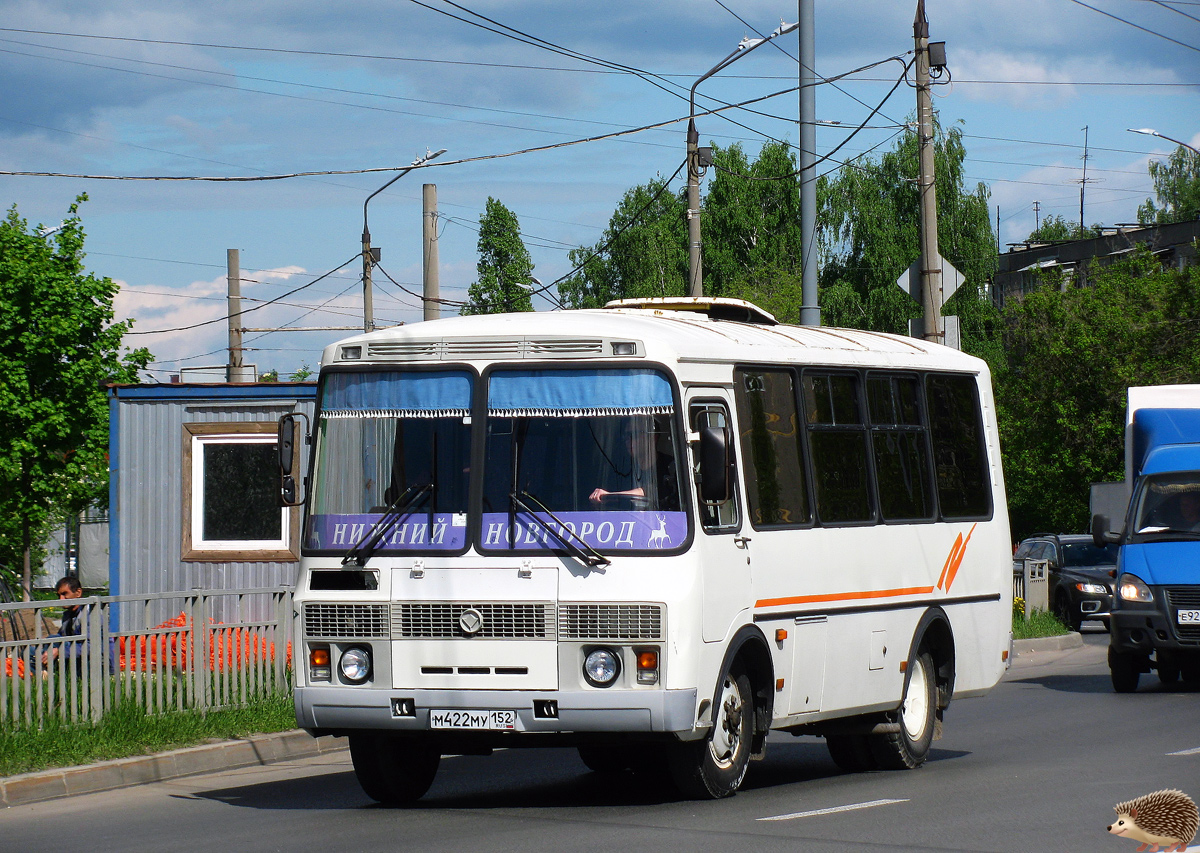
[0,693,296,776]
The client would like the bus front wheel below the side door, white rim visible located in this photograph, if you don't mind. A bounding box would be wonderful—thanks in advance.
[667,668,754,800]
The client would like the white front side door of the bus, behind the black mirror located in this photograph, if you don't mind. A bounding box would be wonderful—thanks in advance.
[688,389,752,643]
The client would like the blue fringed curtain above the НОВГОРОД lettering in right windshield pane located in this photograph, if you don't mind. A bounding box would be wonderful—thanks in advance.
[487,370,673,418]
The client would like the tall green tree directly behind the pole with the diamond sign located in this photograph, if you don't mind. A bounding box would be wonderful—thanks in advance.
[817,122,996,340]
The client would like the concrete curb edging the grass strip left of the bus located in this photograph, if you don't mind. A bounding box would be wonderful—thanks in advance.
[0,729,346,807]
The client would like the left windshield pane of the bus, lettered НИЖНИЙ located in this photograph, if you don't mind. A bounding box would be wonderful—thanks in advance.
[304,371,474,553]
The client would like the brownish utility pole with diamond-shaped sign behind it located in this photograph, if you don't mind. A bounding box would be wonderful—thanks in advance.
[912,0,943,343]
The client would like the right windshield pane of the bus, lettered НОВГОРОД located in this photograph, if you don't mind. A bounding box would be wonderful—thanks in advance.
[482,370,688,552]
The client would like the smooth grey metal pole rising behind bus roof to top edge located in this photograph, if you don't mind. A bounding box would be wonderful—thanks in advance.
[798,0,821,326]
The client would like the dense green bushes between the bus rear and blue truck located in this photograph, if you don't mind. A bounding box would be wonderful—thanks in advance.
[990,251,1200,539]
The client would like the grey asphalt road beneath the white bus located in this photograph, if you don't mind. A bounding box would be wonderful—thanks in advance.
[0,625,1200,853]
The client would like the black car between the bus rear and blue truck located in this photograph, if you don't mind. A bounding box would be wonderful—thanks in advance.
[1013,533,1117,631]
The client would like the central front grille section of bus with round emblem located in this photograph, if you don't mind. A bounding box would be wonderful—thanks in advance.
[391,601,554,639]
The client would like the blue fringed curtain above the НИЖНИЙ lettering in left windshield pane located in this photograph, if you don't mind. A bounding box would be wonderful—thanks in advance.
[322,371,472,418]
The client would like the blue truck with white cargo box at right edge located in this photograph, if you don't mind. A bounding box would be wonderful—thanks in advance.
[1092,385,1200,693]
